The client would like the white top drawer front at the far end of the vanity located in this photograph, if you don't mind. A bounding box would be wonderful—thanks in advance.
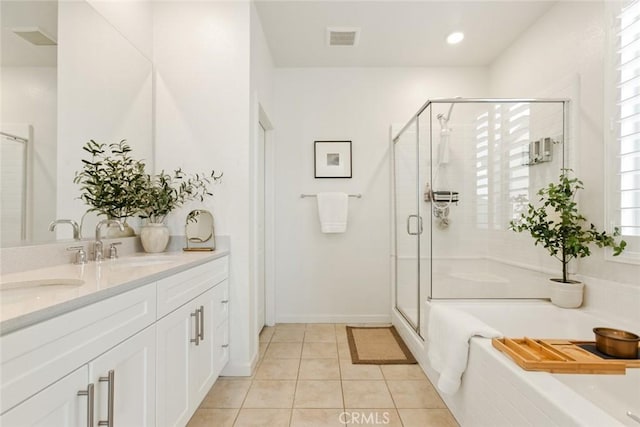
[158,256,229,319]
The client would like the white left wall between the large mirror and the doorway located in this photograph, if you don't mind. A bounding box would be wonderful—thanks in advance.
[153,1,255,375]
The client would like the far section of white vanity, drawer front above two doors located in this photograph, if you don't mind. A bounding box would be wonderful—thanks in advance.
[156,258,228,426]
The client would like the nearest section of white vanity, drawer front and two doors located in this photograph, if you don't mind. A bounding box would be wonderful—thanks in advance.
[0,284,156,427]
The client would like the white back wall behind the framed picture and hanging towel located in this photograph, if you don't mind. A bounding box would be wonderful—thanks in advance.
[275,68,488,322]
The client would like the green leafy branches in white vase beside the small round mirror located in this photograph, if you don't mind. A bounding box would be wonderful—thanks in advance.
[138,169,222,253]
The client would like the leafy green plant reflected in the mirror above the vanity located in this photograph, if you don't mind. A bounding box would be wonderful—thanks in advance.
[73,140,146,237]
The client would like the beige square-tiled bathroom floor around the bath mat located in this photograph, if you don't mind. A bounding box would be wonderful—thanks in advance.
[188,324,458,427]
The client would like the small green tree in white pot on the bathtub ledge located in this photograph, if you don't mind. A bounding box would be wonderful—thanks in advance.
[509,169,627,308]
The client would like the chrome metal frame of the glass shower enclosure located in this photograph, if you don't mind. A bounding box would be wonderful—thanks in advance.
[390,98,571,341]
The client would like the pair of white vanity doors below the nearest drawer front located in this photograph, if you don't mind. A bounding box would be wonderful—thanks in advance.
[0,326,156,427]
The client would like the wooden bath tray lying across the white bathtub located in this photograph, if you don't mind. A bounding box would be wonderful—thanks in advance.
[491,337,640,375]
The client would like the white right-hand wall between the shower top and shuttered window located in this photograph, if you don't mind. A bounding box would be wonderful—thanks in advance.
[490,2,638,283]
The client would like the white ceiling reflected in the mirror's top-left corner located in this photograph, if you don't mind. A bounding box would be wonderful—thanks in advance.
[0,0,58,67]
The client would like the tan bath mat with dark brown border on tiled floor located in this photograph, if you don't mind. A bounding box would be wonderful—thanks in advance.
[347,326,417,365]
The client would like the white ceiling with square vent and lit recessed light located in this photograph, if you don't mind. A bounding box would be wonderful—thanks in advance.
[256,0,555,67]
